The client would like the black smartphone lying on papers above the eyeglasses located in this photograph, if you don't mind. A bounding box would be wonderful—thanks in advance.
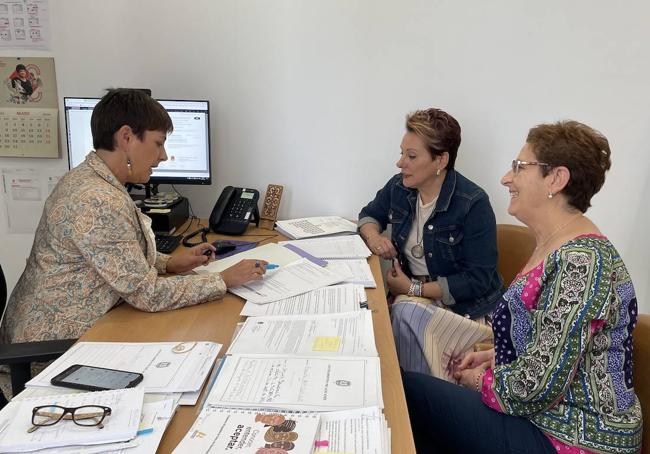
[50,364,144,391]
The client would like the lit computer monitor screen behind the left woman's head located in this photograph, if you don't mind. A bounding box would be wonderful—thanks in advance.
[64,98,211,184]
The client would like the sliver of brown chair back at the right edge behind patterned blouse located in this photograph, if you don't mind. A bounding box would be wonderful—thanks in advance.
[633,314,650,454]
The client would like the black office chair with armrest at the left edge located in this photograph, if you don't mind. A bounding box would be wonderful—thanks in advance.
[0,265,77,402]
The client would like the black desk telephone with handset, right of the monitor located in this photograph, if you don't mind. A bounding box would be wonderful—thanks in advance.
[210,186,260,235]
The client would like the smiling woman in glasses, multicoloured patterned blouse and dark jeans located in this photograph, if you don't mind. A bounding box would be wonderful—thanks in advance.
[404,121,642,454]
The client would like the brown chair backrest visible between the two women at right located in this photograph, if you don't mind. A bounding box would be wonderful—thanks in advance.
[497,224,536,287]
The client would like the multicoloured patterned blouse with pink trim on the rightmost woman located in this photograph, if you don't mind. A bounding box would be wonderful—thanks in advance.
[482,235,643,453]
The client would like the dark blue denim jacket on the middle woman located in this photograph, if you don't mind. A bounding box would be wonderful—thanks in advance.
[359,170,503,318]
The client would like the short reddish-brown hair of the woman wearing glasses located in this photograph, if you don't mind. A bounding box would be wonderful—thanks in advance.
[526,120,612,213]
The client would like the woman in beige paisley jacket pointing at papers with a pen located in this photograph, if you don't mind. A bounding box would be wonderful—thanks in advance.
[2,89,266,342]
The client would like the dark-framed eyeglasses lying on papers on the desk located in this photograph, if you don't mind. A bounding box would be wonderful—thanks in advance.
[27,405,111,433]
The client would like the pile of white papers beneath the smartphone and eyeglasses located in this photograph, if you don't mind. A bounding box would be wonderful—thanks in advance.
[0,342,221,454]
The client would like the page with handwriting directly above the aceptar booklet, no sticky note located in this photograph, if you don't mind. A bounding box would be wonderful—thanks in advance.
[206,355,383,411]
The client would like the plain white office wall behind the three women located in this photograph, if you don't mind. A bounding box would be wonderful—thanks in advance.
[0,0,650,312]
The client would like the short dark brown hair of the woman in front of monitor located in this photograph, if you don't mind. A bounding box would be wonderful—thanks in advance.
[90,88,174,151]
